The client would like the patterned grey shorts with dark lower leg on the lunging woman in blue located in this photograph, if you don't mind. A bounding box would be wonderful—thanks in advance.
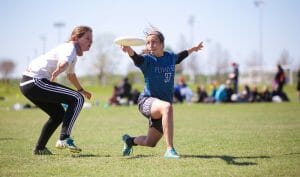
[138,97,163,133]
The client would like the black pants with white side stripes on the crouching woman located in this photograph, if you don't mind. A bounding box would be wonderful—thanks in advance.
[20,76,84,149]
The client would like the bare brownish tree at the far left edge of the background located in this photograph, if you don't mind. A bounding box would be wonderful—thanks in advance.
[0,59,16,83]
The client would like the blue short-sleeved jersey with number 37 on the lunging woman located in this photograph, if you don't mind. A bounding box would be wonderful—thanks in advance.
[137,52,178,103]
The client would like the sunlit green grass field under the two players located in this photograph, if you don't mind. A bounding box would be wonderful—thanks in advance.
[0,84,300,177]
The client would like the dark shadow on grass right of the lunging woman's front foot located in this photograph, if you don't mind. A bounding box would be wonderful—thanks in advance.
[180,155,271,166]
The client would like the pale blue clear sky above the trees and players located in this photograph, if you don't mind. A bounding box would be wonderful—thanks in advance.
[0,0,300,75]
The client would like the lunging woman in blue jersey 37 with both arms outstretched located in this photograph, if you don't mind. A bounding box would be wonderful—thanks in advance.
[121,30,203,158]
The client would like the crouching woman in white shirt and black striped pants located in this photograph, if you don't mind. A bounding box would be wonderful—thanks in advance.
[20,26,93,155]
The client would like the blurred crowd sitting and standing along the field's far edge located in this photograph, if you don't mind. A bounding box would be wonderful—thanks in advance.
[109,62,300,105]
